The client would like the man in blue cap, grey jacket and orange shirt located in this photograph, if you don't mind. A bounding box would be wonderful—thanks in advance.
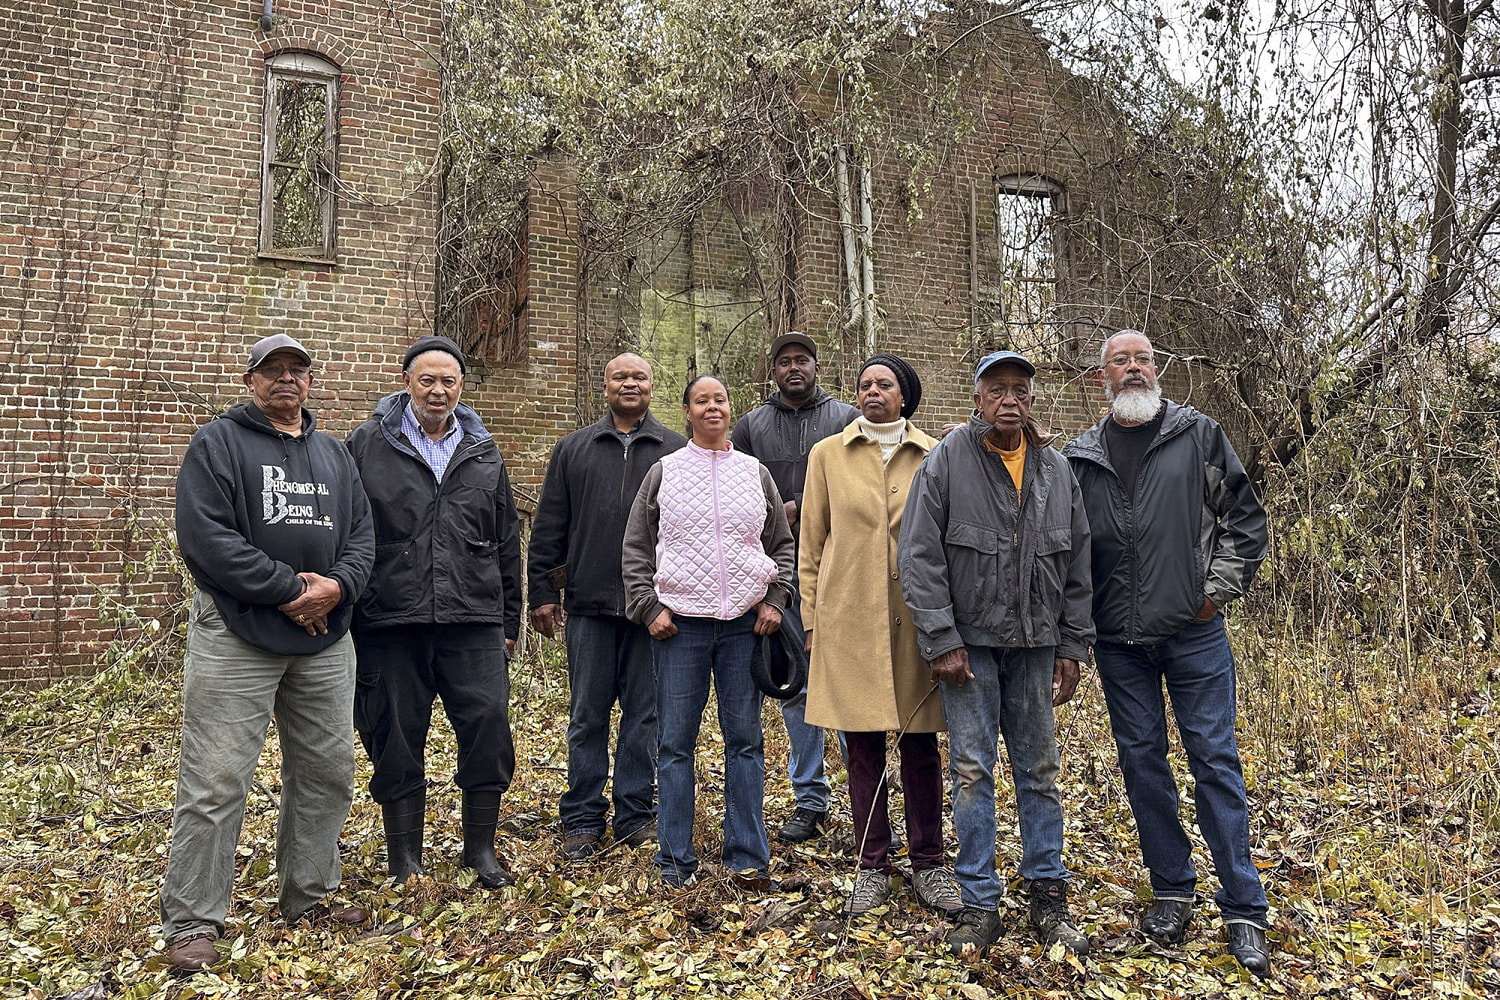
[897,351,1094,955]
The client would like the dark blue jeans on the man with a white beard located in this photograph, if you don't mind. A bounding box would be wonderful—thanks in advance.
[1094,616,1266,927]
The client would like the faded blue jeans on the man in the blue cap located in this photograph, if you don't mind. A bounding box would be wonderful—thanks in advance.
[939,646,1068,910]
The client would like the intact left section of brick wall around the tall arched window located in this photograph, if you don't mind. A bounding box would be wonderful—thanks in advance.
[0,0,441,684]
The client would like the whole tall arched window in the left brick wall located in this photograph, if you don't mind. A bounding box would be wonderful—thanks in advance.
[261,52,339,264]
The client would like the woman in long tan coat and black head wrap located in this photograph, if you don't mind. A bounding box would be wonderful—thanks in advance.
[798,354,963,916]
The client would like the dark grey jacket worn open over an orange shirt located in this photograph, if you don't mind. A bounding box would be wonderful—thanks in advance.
[896,417,1094,661]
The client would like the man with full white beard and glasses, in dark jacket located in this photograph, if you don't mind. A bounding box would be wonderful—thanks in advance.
[1065,330,1271,975]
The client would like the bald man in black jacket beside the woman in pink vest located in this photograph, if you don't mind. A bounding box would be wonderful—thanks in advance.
[527,354,687,861]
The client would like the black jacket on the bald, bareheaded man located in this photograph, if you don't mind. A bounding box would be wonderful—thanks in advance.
[527,411,687,618]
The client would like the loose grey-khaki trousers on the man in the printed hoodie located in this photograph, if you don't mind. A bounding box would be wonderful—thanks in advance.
[161,591,354,942]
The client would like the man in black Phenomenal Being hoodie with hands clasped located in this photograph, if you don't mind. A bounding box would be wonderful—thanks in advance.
[162,334,375,970]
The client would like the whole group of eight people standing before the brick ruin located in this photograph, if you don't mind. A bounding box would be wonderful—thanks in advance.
[162,330,1271,973]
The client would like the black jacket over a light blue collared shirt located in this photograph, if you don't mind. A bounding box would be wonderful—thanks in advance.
[348,393,521,639]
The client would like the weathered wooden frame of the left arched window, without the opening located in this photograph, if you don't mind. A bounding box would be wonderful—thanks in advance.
[258,51,342,265]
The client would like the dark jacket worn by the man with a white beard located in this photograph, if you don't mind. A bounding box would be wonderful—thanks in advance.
[1064,402,1266,643]
